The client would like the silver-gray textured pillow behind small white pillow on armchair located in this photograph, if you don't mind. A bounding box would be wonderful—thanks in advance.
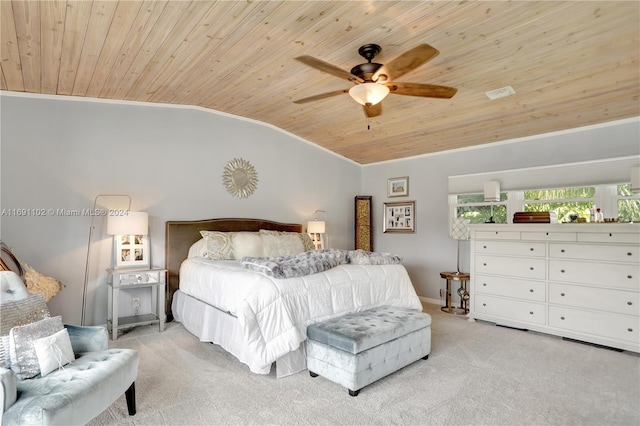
[9,316,64,380]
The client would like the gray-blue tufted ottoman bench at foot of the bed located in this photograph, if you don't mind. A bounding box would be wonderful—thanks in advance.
[307,306,431,396]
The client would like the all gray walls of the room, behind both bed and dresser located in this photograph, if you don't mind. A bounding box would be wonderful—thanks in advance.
[0,92,640,324]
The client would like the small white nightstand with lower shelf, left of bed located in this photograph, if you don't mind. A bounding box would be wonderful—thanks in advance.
[107,268,167,340]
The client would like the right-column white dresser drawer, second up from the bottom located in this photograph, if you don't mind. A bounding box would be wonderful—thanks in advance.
[549,283,640,316]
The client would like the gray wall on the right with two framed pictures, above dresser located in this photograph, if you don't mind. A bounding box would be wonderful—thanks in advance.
[362,120,640,300]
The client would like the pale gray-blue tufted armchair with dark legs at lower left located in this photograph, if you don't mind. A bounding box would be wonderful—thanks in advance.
[0,271,138,425]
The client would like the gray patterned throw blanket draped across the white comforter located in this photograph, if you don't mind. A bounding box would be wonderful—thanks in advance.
[242,249,402,278]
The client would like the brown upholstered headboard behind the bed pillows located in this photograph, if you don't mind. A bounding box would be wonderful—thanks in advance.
[164,218,302,320]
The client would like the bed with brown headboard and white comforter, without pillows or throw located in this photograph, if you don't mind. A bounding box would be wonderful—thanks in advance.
[165,218,422,377]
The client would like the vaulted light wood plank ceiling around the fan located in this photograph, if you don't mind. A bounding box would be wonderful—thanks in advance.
[0,0,640,164]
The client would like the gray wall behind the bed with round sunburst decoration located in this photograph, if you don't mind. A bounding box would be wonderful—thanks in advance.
[0,92,361,324]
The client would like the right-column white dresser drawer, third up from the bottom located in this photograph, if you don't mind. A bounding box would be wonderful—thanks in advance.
[549,259,640,290]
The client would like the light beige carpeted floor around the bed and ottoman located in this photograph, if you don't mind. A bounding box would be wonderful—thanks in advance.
[90,304,640,426]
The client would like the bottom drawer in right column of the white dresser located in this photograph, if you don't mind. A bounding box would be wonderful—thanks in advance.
[549,306,640,343]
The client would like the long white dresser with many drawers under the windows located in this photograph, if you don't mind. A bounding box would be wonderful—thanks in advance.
[468,223,640,352]
